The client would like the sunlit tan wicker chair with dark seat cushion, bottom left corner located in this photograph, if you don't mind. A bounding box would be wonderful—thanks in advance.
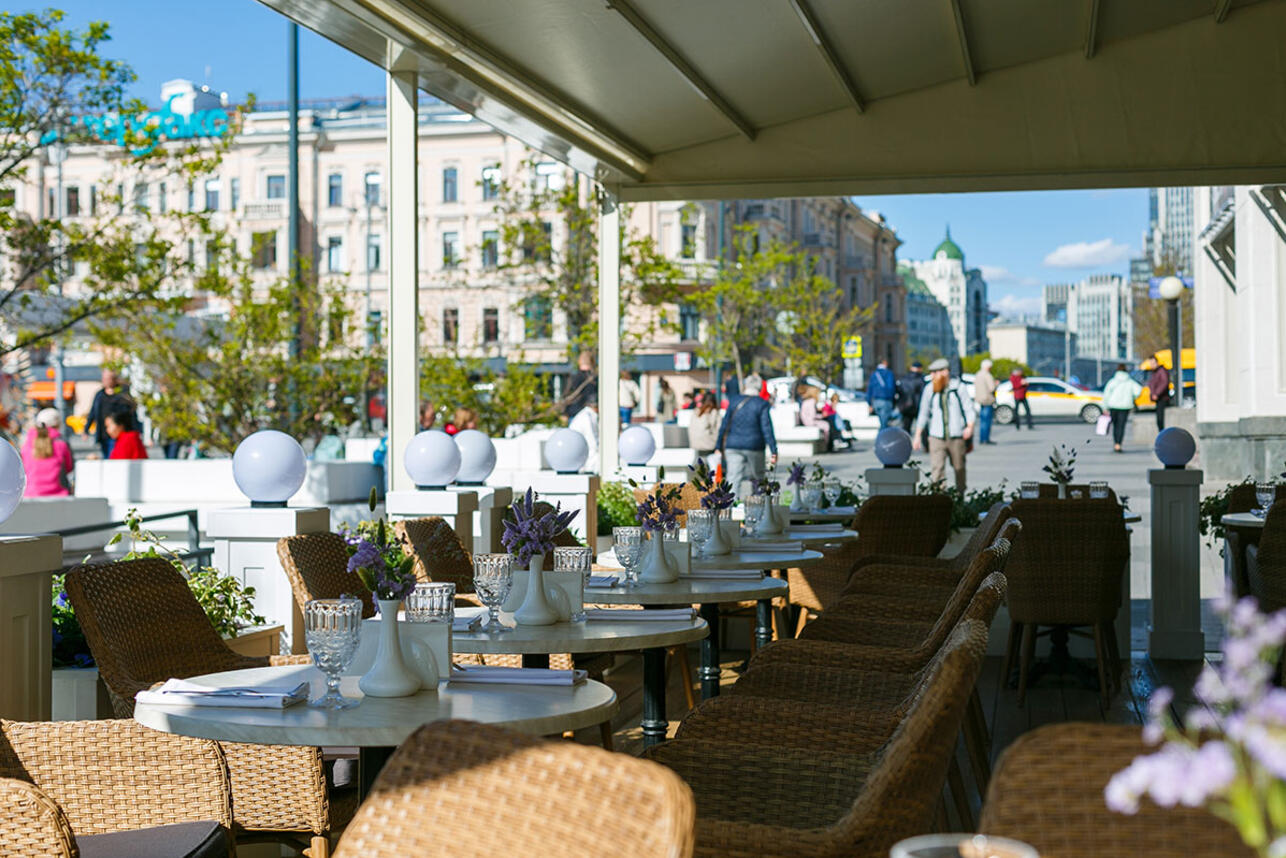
[0,720,233,858]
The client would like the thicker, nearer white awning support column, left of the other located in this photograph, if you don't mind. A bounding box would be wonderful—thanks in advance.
[385,63,419,491]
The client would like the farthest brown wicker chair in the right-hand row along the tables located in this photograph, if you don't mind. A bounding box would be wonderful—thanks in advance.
[786,494,952,634]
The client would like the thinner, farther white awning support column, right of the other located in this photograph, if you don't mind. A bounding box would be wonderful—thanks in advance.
[590,188,621,475]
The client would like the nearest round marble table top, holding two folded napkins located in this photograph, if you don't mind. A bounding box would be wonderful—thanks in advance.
[134,665,620,747]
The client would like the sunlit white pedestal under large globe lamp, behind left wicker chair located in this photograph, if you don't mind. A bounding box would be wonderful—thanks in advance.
[206,507,331,652]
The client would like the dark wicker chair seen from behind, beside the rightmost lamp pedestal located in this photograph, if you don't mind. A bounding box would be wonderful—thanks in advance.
[1001,498,1129,706]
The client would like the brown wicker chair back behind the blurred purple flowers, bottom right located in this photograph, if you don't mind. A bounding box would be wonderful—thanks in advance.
[979,723,1255,858]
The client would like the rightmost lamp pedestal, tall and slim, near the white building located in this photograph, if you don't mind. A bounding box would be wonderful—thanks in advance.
[1147,468,1205,659]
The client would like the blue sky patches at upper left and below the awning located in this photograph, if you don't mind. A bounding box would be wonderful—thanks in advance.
[40,0,1147,313]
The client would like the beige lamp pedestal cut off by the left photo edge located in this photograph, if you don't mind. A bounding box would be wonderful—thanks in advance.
[0,534,63,720]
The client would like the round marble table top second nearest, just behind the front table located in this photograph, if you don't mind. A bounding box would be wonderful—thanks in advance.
[451,614,710,655]
